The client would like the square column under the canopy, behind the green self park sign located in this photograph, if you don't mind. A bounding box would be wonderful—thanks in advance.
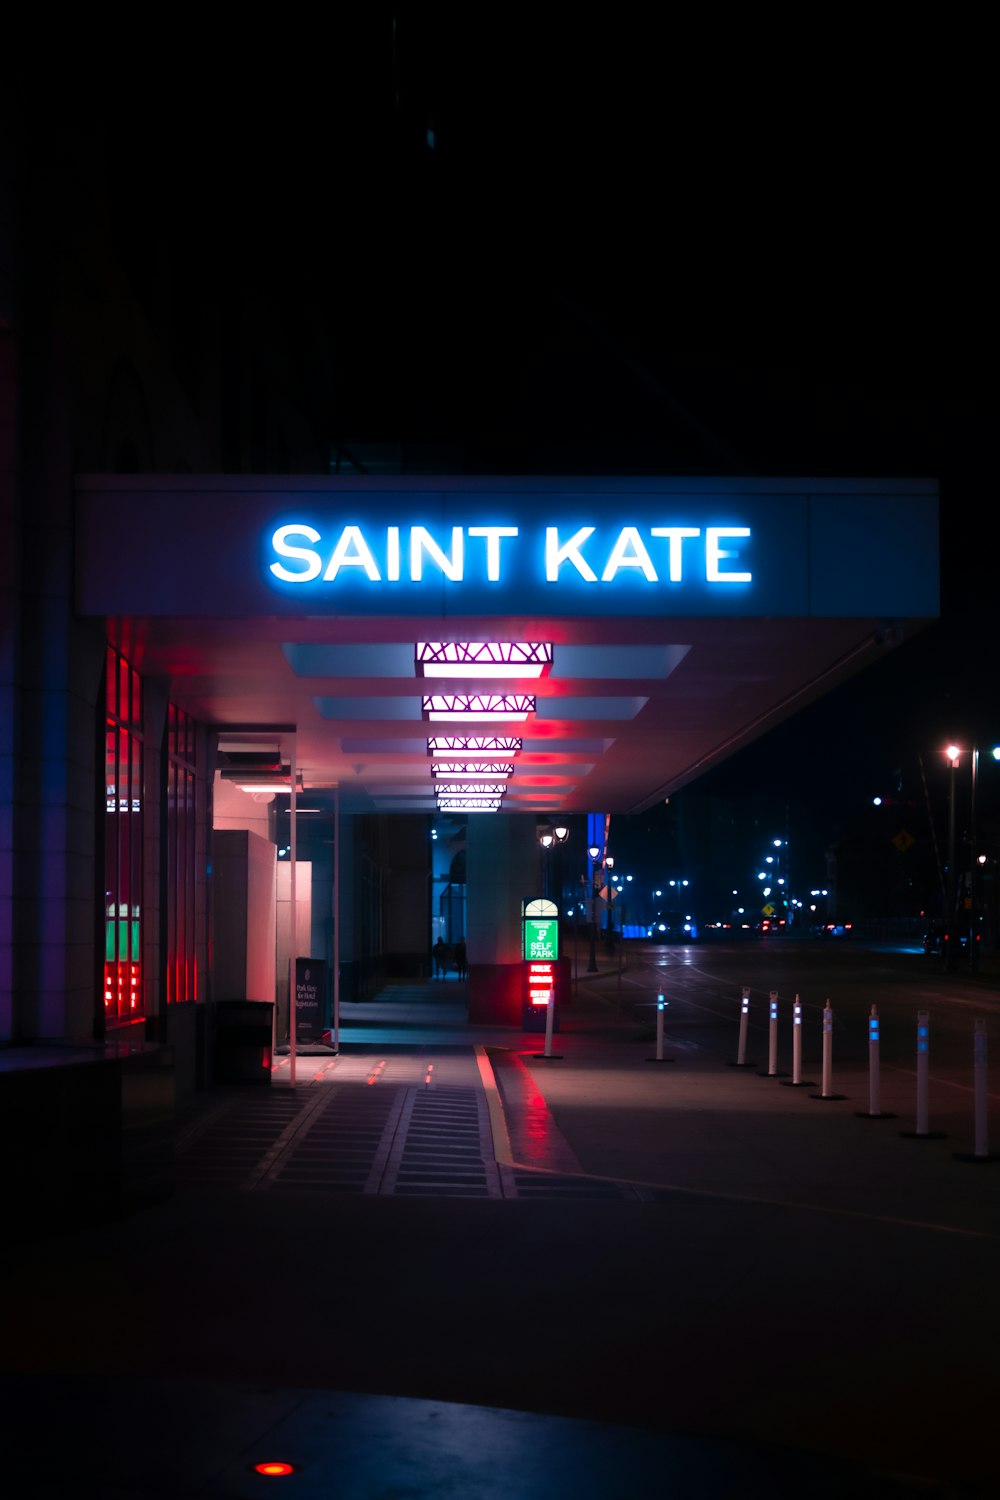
[465,813,541,1028]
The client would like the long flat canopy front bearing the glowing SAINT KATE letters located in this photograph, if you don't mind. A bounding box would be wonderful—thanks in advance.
[75,476,939,624]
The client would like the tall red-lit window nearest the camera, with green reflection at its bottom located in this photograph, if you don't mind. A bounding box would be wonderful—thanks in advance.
[103,647,145,1026]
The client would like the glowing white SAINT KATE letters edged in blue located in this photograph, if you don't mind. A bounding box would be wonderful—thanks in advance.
[268,522,753,585]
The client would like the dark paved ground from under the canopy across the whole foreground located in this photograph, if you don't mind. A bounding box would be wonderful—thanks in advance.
[0,975,1000,1500]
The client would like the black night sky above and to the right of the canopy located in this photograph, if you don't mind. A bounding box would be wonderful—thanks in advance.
[7,17,1000,906]
